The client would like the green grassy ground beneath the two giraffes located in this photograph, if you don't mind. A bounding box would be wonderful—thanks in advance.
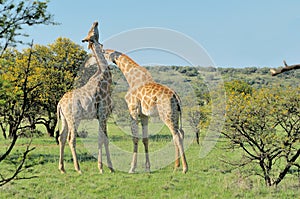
[0,121,300,198]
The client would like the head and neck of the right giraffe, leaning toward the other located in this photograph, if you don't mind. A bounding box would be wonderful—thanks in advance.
[104,49,153,89]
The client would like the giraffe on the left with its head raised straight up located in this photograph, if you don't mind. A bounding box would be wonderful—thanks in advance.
[57,22,114,173]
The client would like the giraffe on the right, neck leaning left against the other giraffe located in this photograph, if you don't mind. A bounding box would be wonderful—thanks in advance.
[104,49,188,173]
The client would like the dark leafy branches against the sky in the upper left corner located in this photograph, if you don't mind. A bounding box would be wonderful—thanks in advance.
[0,0,57,57]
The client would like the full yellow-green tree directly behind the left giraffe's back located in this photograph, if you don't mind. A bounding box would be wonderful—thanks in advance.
[30,38,87,136]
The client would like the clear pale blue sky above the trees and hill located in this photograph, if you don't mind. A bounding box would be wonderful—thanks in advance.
[25,0,300,67]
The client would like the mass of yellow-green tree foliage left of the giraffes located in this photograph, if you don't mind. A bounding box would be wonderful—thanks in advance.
[0,38,87,134]
